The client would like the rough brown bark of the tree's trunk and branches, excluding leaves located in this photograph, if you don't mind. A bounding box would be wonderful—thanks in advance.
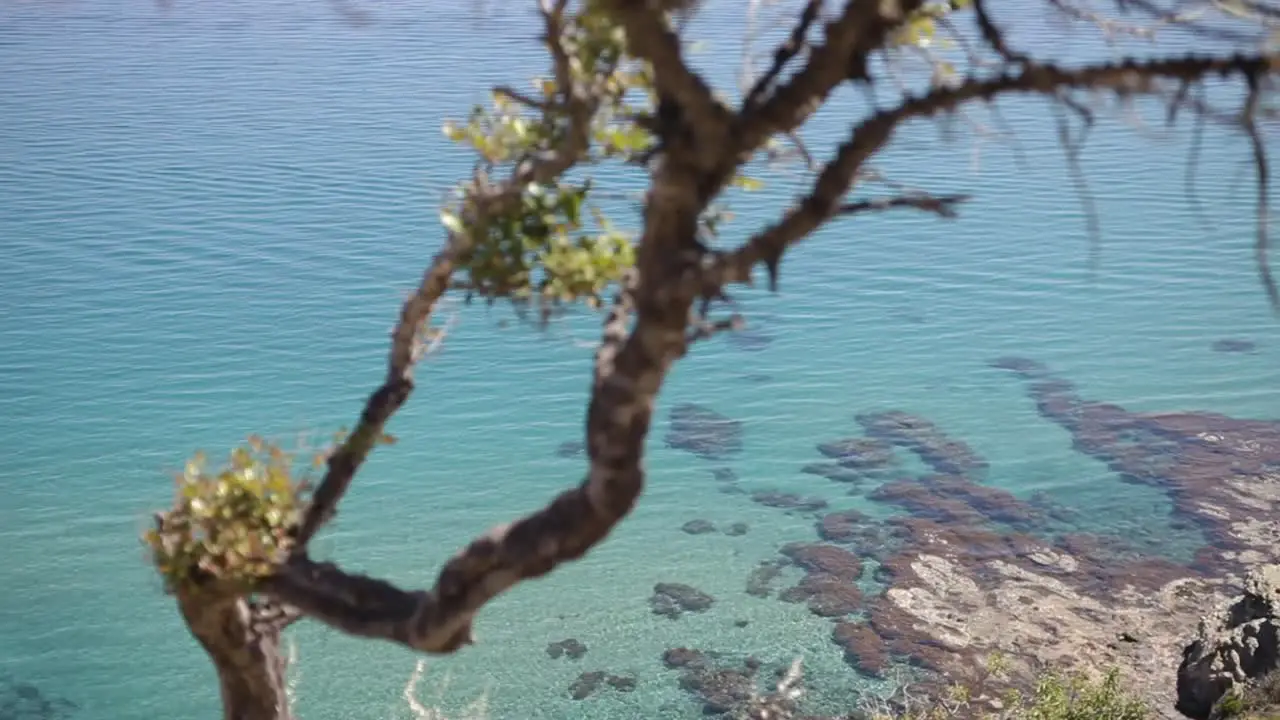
[165,0,1280,720]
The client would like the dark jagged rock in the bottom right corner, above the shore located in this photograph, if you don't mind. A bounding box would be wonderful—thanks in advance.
[1178,565,1280,720]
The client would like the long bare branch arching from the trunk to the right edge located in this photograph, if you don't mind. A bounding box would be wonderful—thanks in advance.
[699,54,1280,293]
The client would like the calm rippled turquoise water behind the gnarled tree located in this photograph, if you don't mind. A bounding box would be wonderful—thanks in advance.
[0,0,1280,720]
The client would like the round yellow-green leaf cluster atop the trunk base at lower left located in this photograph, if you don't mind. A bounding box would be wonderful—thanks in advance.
[143,436,306,592]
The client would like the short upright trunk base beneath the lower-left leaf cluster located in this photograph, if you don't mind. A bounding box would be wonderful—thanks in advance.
[178,592,293,720]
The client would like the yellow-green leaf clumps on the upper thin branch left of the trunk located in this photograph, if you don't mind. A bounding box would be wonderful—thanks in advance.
[440,1,654,311]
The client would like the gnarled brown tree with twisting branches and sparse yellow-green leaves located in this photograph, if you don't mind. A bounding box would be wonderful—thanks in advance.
[146,0,1280,720]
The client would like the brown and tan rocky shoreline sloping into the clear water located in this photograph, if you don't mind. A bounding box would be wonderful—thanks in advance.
[640,357,1280,719]
